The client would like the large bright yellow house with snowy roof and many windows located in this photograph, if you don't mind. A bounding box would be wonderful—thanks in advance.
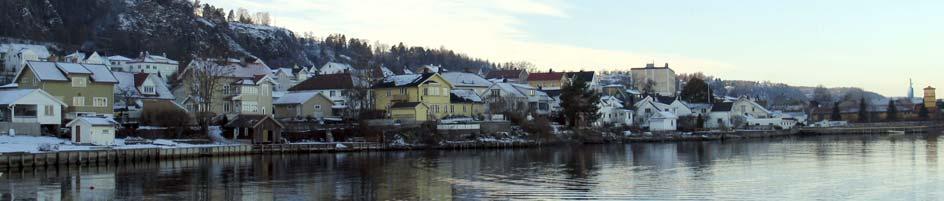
[371,73,453,121]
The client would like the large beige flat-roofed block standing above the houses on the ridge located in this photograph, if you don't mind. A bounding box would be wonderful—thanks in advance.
[631,63,678,96]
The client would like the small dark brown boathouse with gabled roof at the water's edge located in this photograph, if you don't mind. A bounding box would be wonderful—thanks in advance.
[224,115,285,144]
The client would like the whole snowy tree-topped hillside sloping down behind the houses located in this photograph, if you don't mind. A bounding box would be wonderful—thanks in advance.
[0,0,494,71]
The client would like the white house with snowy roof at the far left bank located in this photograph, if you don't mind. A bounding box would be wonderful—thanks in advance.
[0,89,67,135]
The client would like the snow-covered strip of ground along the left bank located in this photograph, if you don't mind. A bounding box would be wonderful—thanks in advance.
[0,135,230,153]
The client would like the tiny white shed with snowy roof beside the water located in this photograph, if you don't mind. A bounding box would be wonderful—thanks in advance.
[66,117,118,146]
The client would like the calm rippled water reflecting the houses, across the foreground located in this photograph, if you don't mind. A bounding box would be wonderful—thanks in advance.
[0,135,944,200]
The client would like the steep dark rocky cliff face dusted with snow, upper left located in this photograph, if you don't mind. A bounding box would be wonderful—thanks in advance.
[0,0,312,66]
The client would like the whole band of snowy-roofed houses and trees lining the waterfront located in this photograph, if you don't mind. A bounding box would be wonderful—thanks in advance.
[0,44,942,152]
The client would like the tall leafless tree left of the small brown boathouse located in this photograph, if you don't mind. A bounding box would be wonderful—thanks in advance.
[184,60,233,134]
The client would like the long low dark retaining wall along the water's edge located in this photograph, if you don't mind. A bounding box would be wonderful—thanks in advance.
[0,125,944,171]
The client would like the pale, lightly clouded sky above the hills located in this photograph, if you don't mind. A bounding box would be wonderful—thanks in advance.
[203,0,944,97]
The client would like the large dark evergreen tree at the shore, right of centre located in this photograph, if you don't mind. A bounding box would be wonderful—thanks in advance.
[561,78,600,127]
